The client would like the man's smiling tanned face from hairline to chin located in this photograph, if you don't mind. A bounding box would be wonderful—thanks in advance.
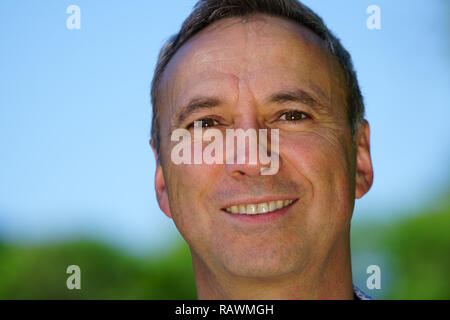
[156,15,367,277]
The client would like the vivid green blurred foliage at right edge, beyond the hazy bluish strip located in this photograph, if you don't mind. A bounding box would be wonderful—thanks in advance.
[384,203,450,299]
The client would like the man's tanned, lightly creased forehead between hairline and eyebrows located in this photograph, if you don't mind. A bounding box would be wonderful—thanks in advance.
[160,14,340,121]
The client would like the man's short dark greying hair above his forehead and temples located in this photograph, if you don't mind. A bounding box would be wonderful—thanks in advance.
[151,0,364,160]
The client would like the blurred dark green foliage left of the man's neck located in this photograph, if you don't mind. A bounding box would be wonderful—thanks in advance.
[0,241,196,299]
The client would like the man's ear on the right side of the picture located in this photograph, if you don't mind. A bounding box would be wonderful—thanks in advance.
[355,120,373,199]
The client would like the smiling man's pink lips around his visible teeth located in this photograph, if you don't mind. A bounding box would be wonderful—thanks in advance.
[221,198,298,225]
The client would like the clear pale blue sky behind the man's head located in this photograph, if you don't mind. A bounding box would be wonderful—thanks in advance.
[0,0,450,254]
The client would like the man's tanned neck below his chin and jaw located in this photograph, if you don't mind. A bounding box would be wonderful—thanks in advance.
[191,234,353,300]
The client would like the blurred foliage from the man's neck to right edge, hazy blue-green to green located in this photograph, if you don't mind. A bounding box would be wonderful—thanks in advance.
[352,195,450,299]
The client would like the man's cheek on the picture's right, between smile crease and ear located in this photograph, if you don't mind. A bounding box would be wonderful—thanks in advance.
[280,133,354,227]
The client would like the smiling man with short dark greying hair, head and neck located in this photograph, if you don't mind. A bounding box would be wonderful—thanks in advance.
[151,0,373,299]
